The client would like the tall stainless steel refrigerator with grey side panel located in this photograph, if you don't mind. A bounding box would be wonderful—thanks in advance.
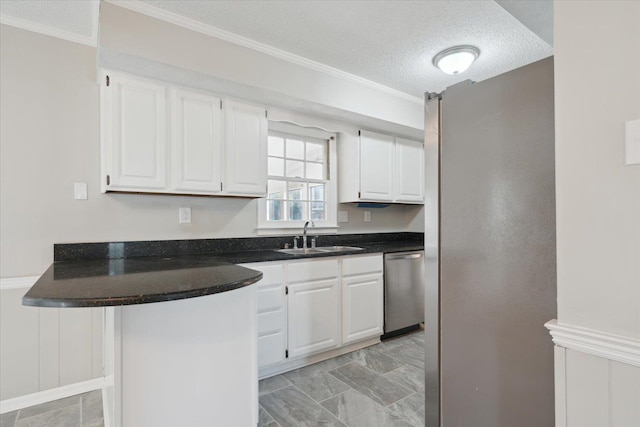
[425,58,556,427]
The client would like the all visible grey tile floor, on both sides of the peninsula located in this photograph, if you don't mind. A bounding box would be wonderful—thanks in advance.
[0,331,424,427]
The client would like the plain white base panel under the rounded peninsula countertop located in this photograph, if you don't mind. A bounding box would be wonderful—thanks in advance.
[105,286,258,427]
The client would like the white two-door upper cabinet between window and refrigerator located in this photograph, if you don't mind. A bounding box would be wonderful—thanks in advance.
[338,131,424,204]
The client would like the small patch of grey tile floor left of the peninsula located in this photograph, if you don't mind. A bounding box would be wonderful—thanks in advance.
[0,390,104,427]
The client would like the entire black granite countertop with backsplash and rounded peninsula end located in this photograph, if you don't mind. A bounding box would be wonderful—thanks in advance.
[22,233,424,307]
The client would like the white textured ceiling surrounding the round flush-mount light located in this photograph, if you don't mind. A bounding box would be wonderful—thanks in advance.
[138,0,553,97]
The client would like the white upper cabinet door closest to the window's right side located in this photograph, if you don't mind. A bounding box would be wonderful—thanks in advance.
[360,131,395,202]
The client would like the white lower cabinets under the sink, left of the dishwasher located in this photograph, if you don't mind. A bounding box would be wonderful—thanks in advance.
[248,254,383,372]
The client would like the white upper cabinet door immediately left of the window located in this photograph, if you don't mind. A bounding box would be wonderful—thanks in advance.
[223,100,267,196]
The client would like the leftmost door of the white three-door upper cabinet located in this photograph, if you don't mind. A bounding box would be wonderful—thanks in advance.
[103,73,167,191]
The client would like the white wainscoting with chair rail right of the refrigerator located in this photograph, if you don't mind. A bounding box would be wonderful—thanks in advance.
[546,321,640,427]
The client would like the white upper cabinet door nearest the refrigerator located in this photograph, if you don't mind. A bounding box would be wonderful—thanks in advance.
[395,138,424,203]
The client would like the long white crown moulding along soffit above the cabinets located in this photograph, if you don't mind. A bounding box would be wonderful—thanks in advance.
[105,0,424,105]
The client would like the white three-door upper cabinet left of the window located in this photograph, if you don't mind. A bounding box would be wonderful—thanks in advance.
[101,72,267,197]
